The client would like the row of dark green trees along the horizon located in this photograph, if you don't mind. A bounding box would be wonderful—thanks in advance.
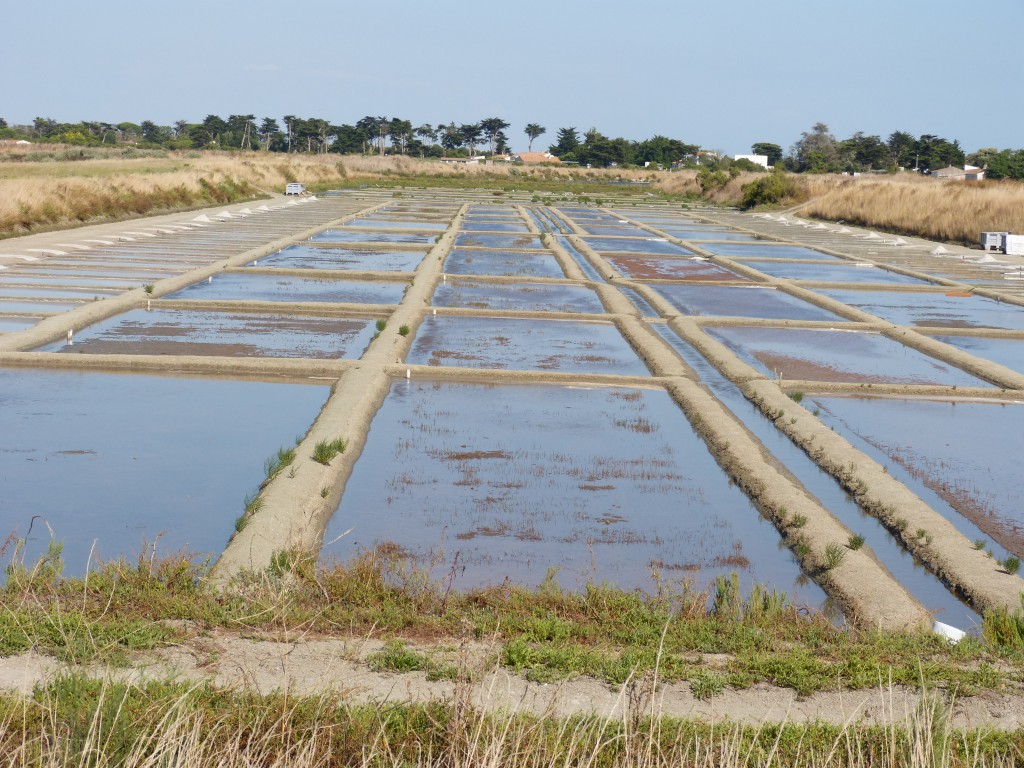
[6,115,1024,179]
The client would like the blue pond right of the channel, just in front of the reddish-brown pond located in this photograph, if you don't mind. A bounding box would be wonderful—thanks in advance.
[652,285,842,321]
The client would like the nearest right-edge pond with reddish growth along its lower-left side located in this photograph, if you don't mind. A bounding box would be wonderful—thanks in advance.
[811,395,1024,567]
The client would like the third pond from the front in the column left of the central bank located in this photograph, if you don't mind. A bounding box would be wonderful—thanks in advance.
[166,272,406,304]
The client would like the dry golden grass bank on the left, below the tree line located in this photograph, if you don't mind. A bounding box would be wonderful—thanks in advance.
[0,147,669,238]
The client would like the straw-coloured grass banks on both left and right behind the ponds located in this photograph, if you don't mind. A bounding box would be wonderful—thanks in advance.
[0,147,1024,244]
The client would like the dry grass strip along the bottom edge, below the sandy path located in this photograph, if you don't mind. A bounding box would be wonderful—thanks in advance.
[0,676,1024,767]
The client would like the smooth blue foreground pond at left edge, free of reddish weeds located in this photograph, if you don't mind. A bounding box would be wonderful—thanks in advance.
[0,369,330,574]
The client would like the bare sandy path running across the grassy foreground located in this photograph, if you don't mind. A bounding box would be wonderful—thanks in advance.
[0,631,1024,730]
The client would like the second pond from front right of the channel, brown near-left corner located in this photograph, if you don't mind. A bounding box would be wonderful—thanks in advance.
[706,328,987,386]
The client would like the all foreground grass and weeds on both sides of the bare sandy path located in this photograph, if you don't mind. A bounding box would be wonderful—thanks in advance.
[0,547,1024,766]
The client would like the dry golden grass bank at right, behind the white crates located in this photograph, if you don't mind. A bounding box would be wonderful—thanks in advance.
[801,174,1024,245]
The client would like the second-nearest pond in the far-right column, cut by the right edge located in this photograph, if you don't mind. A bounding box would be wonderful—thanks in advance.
[816,289,1024,331]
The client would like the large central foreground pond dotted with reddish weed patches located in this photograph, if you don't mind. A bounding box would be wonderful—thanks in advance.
[322,381,824,606]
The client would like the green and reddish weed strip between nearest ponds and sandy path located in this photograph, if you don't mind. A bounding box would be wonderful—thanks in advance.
[0,548,1024,695]
